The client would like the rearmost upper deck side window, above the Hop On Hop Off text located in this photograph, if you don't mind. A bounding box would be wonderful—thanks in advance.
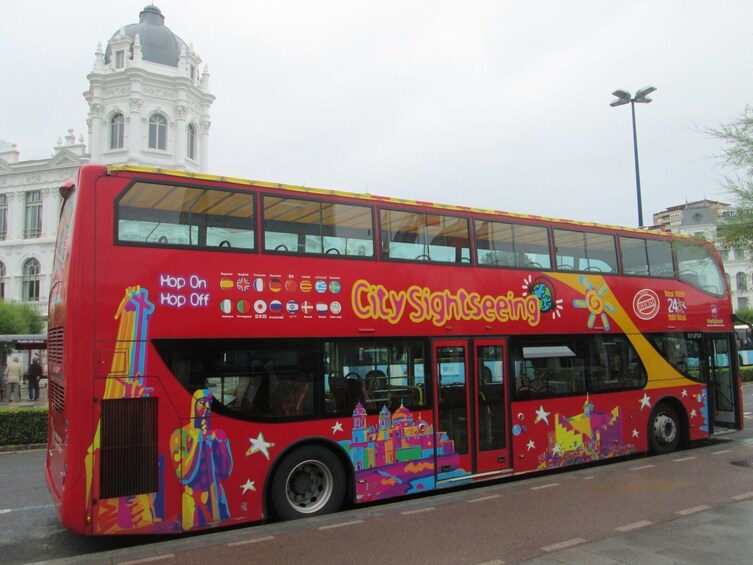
[117,182,256,249]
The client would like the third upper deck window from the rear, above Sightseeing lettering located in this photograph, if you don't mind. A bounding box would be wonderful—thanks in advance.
[382,210,471,263]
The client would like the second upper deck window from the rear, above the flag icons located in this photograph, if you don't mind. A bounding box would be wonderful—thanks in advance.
[264,195,374,257]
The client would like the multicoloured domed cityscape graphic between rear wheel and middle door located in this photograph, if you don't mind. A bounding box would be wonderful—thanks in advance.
[340,403,467,502]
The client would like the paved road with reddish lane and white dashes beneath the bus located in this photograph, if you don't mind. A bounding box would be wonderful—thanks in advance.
[0,387,753,565]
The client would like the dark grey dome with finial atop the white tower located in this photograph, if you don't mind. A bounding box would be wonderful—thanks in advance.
[105,4,188,67]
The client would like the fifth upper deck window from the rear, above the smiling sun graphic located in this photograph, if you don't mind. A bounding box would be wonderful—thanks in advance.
[554,229,617,273]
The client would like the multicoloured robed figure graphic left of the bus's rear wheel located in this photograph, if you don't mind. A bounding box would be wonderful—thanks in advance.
[170,389,233,530]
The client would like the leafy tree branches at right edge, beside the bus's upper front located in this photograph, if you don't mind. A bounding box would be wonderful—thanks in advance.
[708,106,753,248]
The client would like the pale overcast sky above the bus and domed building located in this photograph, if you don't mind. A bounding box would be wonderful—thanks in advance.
[0,0,753,226]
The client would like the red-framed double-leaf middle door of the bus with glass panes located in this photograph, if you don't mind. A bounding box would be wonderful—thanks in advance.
[434,339,511,480]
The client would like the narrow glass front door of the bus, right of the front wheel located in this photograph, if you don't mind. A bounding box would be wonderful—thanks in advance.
[708,336,741,428]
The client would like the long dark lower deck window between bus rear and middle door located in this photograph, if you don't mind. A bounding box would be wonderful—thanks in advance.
[154,338,430,420]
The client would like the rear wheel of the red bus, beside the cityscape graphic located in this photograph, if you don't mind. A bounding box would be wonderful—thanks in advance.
[272,446,345,520]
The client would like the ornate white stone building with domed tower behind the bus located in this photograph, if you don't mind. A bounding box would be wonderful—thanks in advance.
[0,5,214,330]
